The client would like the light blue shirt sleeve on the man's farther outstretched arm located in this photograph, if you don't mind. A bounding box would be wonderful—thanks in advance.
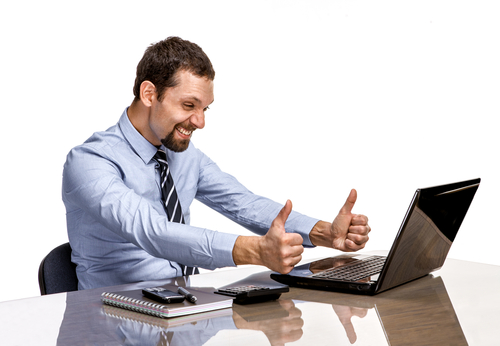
[196,151,319,247]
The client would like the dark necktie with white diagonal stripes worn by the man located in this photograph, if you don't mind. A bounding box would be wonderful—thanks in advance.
[154,149,199,275]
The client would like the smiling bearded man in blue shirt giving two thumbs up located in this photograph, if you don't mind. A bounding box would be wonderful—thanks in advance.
[62,37,370,289]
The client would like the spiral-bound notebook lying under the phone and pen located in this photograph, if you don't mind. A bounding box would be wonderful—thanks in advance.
[101,285,233,318]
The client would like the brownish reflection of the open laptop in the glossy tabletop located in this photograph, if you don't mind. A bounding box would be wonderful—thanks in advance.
[304,274,468,346]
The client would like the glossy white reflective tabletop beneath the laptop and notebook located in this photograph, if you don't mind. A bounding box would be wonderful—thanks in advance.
[0,259,500,346]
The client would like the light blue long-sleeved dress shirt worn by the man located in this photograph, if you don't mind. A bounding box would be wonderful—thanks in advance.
[62,109,318,289]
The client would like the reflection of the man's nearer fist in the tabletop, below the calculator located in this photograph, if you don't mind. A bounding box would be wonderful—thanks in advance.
[233,299,304,346]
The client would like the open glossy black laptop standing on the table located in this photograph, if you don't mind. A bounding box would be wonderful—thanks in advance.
[271,179,481,295]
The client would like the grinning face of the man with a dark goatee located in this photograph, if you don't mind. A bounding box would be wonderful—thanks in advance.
[149,71,214,152]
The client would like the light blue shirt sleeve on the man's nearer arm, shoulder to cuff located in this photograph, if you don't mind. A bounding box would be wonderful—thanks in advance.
[63,145,237,269]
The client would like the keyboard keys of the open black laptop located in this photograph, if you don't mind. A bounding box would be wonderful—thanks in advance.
[311,256,386,281]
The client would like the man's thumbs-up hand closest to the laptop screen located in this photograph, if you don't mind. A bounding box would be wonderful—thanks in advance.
[309,189,371,252]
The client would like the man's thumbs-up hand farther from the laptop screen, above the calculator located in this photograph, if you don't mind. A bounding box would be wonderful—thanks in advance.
[233,200,304,274]
